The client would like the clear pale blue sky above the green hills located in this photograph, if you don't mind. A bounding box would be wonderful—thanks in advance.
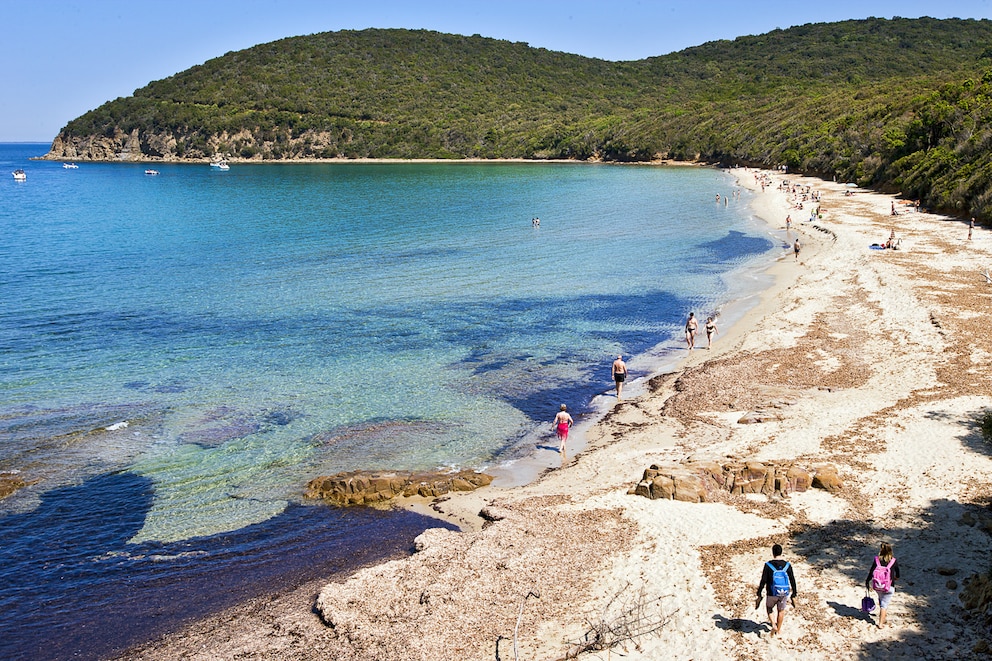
[0,0,992,142]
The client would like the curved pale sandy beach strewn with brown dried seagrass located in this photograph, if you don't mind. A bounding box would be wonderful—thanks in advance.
[120,169,992,661]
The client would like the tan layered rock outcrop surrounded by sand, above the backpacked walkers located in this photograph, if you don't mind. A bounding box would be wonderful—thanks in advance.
[628,461,841,503]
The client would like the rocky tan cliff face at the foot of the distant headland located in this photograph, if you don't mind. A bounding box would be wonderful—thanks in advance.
[43,127,351,162]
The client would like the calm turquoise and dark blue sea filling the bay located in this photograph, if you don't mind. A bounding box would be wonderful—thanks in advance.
[0,145,777,659]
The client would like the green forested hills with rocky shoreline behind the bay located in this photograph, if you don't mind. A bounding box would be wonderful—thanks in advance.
[49,18,992,217]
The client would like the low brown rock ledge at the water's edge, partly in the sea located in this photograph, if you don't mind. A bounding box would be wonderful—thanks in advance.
[306,470,493,505]
